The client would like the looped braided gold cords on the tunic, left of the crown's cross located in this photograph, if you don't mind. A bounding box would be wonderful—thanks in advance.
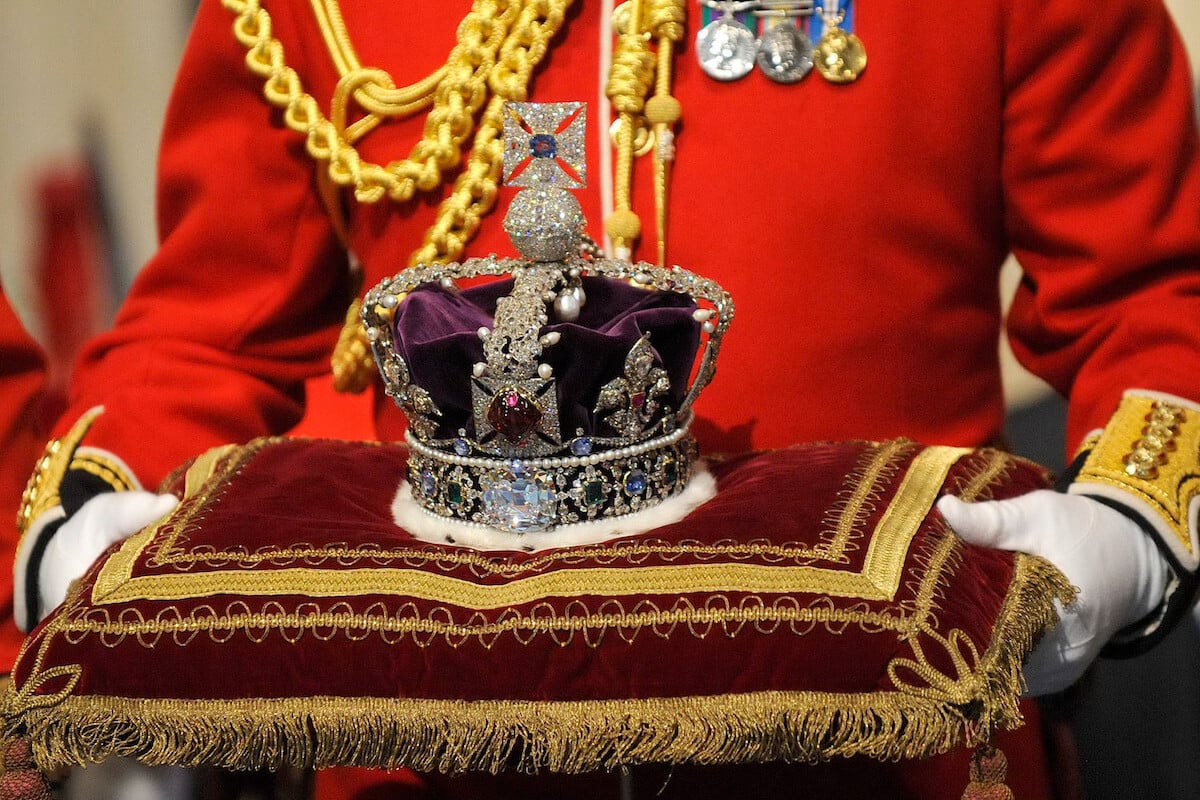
[222,0,571,392]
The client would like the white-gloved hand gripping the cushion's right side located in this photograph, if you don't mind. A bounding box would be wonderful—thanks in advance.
[937,491,1171,694]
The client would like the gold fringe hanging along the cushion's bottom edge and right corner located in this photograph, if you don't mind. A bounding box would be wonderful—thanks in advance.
[4,555,1074,772]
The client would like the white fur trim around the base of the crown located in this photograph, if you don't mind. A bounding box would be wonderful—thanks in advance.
[391,463,716,553]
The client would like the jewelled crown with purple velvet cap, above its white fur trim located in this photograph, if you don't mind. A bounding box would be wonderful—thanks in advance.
[361,103,733,534]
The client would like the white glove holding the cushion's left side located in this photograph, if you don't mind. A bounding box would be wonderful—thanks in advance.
[37,492,179,619]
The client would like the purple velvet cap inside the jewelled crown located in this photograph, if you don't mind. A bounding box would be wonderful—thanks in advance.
[392,277,700,441]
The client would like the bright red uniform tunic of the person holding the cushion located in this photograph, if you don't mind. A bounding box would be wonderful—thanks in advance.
[37,0,1200,798]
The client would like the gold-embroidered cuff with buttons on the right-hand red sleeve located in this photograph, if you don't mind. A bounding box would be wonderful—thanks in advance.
[1072,390,1200,572]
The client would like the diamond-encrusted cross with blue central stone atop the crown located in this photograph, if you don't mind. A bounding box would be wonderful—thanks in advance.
[504,103,588,188]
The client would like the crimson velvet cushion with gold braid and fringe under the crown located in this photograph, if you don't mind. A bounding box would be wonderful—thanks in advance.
[5,439,1070,771]
